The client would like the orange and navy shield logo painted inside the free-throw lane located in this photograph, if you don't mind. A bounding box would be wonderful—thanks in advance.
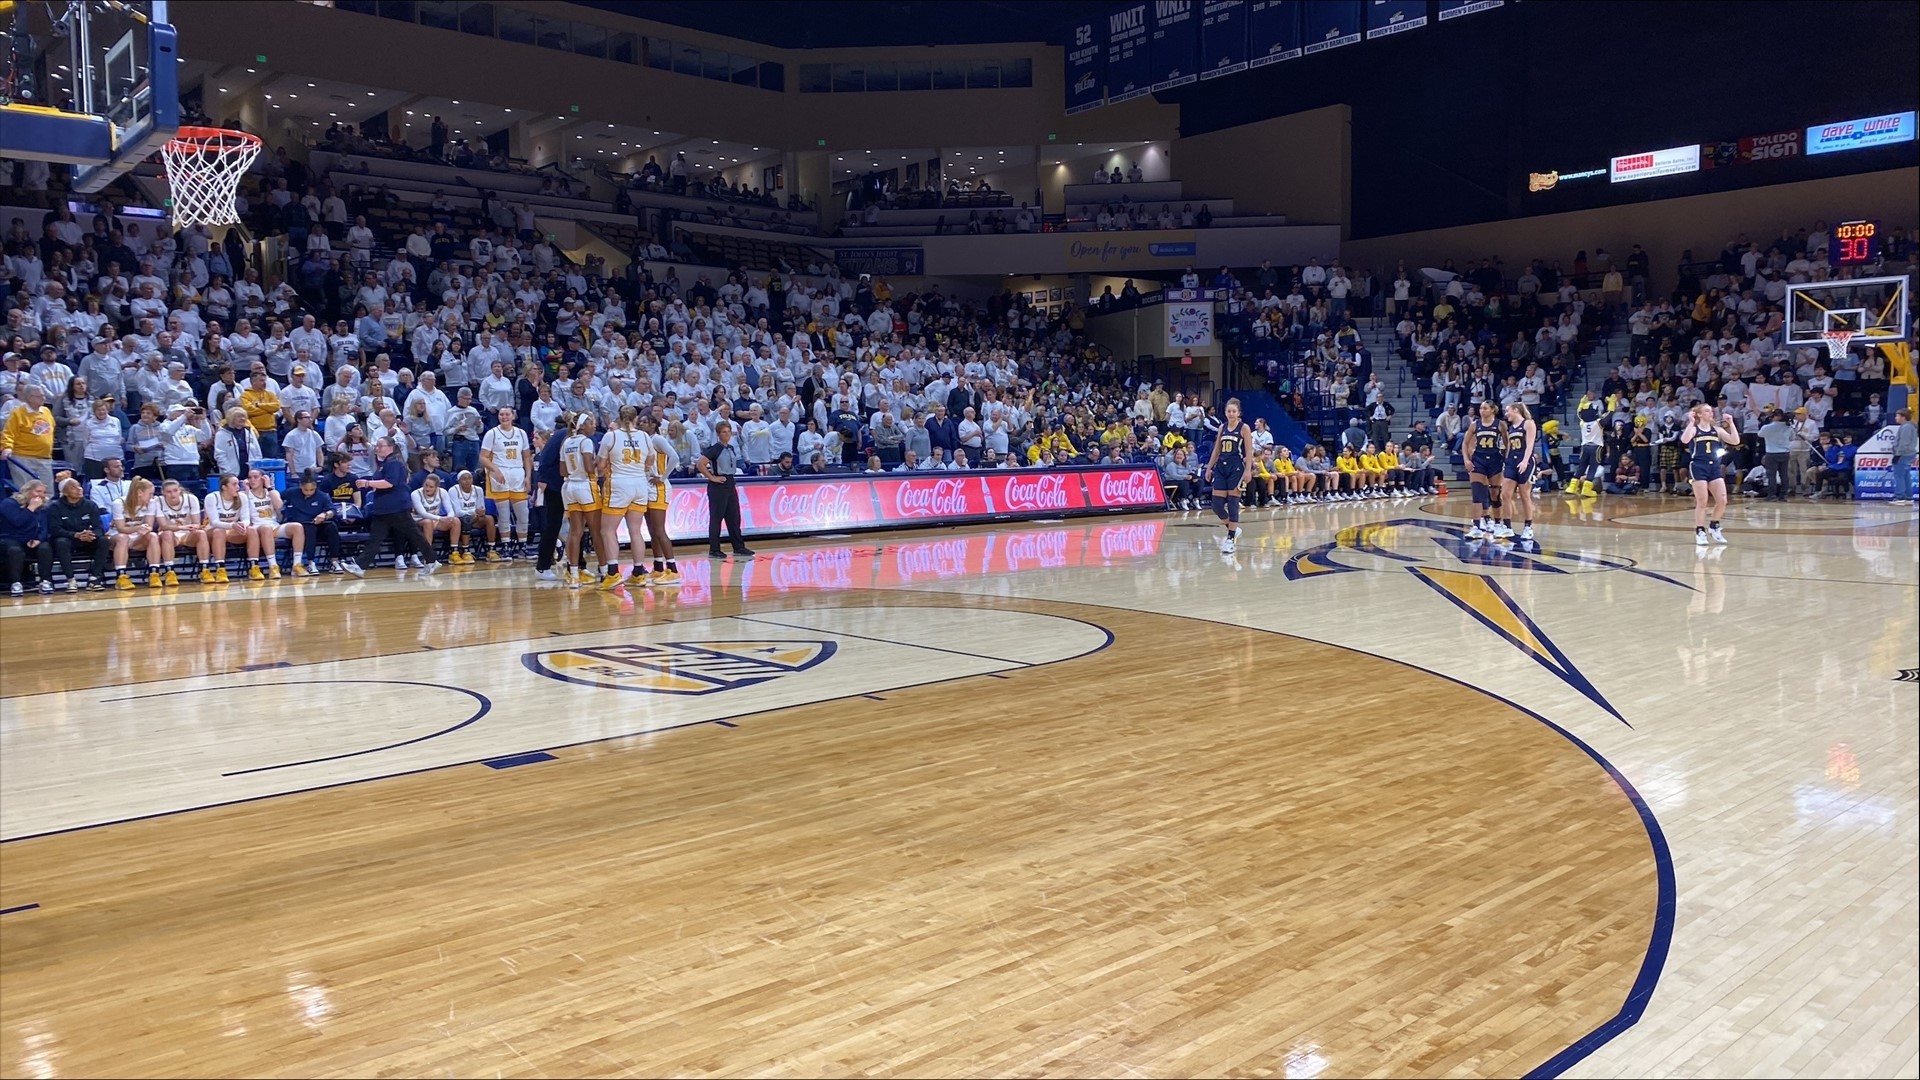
[520,642,837,698]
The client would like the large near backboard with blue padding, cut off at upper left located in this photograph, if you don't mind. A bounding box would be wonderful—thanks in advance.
[0,0,180,192]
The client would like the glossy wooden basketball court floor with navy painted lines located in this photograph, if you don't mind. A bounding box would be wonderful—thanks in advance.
[0,500,1920,1076]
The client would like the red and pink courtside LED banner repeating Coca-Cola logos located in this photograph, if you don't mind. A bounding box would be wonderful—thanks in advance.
[629,465,1165,542]
